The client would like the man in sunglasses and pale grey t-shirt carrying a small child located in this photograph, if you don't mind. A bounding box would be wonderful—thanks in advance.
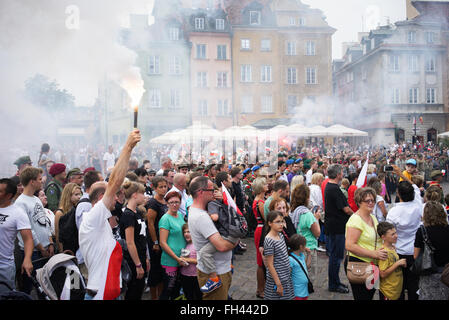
[188,176,238,300]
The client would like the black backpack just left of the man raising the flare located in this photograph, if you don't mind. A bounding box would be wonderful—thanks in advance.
[59,198,89,254]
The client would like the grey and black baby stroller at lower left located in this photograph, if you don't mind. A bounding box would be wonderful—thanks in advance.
[31,253,86,300]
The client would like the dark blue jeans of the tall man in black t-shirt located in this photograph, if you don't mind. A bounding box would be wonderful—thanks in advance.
[327,234,345,289]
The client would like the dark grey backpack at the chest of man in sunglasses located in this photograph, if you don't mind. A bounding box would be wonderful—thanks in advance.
[208,201,248,238]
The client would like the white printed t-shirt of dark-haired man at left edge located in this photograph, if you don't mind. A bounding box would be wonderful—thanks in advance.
[0,204,31,269]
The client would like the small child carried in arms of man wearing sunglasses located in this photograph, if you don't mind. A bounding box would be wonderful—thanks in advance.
[198,196,240,293]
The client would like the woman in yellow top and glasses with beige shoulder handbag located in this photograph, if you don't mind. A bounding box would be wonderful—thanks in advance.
[345,188,387,300]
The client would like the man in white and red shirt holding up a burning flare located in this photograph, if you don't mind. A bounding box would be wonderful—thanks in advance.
[79,129,142,300]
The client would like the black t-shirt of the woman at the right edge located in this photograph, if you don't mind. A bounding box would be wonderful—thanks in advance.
[415,226,449,267]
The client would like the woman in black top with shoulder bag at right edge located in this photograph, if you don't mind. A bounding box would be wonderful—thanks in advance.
[413,201,449,300]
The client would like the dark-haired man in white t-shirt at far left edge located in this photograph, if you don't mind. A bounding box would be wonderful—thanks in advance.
[0,179,34,293]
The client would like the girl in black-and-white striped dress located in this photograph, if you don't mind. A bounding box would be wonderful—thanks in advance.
[263,211,294,300]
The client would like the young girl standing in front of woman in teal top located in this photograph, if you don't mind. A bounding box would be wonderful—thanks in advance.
[181,223,202,300]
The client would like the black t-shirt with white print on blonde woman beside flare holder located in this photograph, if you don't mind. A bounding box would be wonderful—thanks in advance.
[120,208,147,270]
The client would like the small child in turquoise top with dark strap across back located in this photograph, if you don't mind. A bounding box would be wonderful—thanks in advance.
[288,234,310,300]
